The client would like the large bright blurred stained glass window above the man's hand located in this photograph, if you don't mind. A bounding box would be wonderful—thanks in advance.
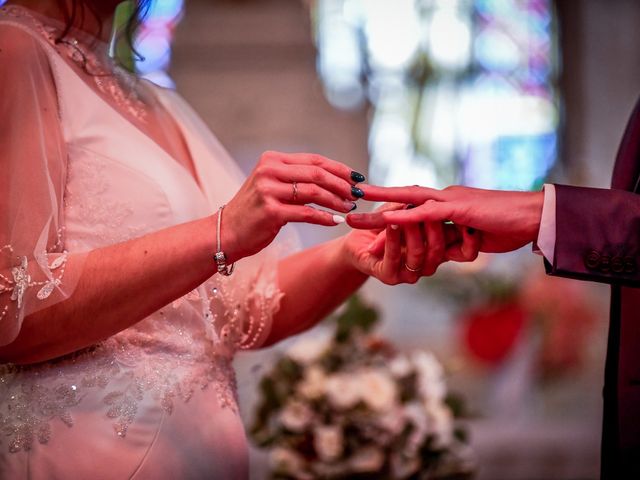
[315,0,559,189]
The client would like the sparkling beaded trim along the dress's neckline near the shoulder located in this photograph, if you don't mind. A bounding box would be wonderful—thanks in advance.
[0,6,147,122]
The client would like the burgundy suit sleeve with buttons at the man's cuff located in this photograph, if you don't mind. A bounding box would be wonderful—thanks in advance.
[545,185,640,287]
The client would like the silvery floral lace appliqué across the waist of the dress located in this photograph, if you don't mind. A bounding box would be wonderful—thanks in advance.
[0,330,237,453]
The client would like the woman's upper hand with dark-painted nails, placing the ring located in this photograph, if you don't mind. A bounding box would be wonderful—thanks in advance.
[221,152,364,262]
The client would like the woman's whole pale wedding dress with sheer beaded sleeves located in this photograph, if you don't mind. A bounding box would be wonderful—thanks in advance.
[0,6,288,480]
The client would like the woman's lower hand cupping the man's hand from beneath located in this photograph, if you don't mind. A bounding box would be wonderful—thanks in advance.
[343,203,480,285]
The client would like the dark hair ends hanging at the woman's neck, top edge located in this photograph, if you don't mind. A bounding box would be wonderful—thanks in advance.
[56,0,153,57]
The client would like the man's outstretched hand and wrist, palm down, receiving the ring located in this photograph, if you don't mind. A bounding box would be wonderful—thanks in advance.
[347,185,544,252]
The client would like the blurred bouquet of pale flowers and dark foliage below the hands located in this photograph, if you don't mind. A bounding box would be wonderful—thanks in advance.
[251,297,473,479]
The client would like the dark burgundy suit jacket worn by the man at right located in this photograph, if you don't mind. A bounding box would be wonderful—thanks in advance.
[545,101,640,480]
